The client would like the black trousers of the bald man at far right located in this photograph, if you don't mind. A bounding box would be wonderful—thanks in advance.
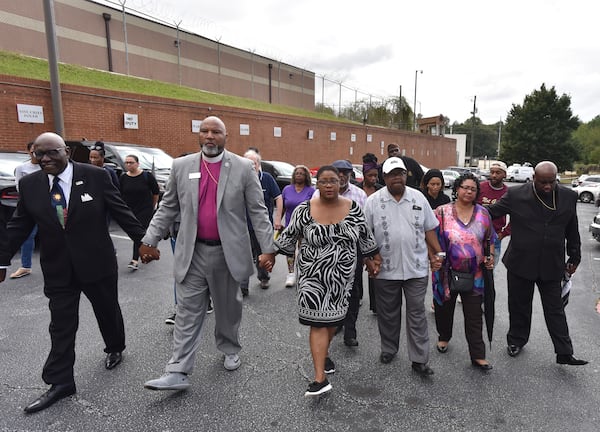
[506,271,573,355]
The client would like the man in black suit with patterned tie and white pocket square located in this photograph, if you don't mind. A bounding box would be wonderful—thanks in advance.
[0,132,144,413]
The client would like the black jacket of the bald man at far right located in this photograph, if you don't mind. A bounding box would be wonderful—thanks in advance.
[488,183,581,280]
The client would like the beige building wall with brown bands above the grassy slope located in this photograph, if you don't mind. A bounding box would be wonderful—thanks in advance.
[0,0,315,110]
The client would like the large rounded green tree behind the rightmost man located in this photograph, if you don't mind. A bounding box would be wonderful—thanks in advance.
[501,84,579,171]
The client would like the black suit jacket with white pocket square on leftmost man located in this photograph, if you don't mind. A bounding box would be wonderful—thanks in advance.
[7,162,145,287]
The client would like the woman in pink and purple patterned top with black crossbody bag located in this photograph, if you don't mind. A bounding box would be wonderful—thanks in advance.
[432,173,496,370]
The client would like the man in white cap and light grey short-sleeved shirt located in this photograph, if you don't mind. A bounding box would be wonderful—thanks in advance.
[364,157,442,376]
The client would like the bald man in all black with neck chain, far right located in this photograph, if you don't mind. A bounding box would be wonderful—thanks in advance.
[488,161,587,365]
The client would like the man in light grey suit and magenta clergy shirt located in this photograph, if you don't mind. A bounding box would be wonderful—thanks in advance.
[140,117,275,390]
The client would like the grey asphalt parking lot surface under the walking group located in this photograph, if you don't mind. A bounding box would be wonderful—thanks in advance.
[0,203,600,432]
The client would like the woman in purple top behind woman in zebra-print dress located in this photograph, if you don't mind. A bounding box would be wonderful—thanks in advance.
[281,165,315,288]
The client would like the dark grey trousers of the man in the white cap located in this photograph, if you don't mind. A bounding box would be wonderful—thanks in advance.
[373,276,429,363]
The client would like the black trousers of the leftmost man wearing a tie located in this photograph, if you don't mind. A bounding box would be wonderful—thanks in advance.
[42,274,125,384]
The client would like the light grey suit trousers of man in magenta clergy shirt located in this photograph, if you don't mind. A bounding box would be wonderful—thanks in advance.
[165,243,242,373]
